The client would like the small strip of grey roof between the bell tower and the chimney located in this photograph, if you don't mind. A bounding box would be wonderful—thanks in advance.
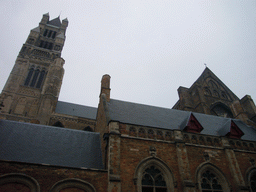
[55,101,97,119]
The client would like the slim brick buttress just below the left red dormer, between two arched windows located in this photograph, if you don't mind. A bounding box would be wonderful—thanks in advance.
[174,131,195,192]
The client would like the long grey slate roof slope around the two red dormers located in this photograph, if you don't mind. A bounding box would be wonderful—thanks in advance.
[106,99,256,141]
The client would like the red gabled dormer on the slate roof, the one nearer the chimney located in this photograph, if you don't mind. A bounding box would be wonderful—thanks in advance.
[180,113,204,133]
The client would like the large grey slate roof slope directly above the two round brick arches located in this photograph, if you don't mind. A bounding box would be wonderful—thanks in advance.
[0,120,104,169]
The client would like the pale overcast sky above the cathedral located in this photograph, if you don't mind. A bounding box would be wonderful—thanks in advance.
[0,0,256,108]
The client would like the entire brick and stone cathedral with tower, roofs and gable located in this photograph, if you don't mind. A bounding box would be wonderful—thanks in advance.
[0,13,256,192]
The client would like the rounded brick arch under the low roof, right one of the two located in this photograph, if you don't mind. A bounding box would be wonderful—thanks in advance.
[50,178,96,192]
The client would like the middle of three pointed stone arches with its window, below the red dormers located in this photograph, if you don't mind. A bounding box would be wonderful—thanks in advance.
[196,162,230,192]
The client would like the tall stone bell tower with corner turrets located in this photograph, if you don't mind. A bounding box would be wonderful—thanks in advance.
[0,13,68,124]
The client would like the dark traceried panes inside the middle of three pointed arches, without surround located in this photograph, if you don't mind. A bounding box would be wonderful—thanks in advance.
[201,170,223,192]
